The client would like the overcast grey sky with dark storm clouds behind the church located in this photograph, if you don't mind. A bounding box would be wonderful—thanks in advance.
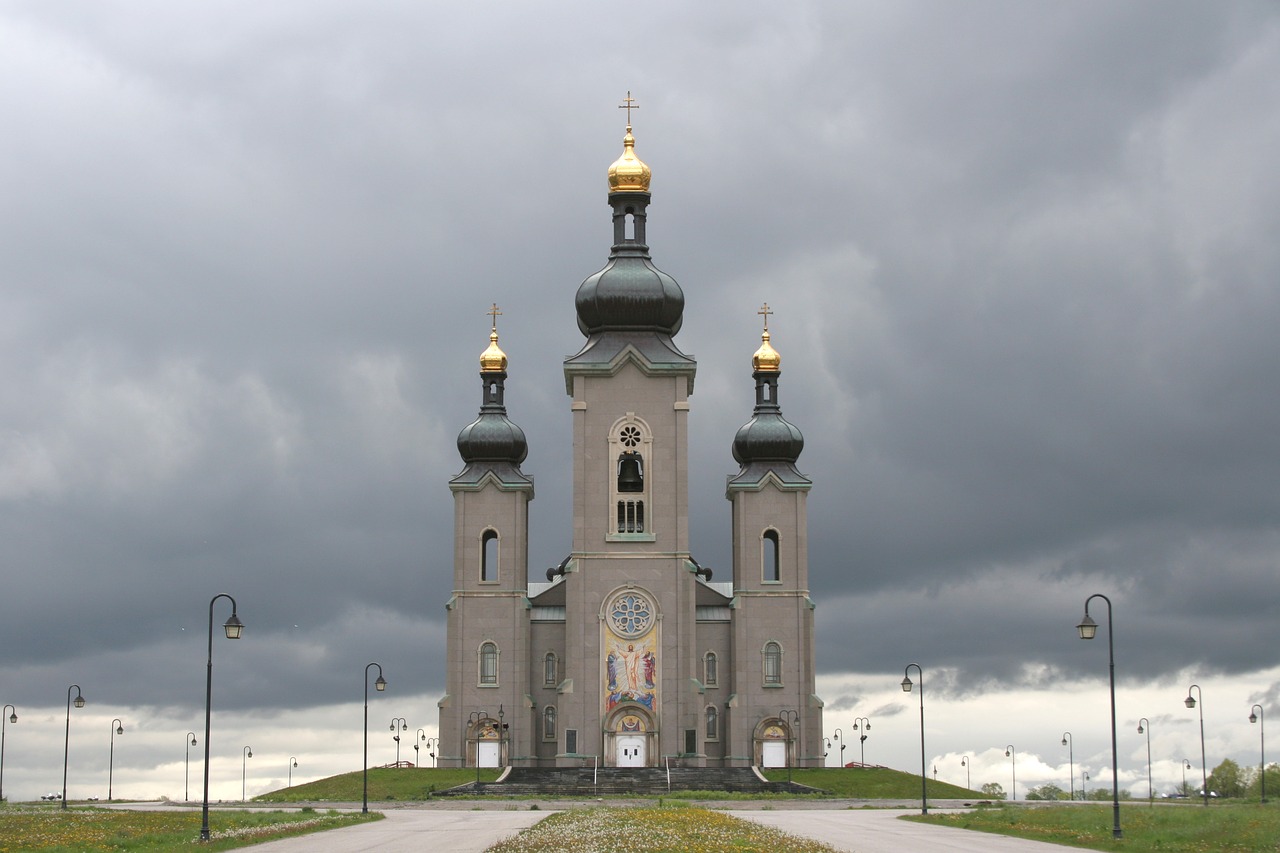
[0,0,1280,799]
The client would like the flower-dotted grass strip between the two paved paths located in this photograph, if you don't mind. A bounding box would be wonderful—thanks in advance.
[488,807,835,853]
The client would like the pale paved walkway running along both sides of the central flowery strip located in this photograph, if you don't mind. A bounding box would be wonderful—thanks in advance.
[227,802,1078,853]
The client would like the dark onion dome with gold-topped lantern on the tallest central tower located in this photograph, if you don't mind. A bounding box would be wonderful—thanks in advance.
[573,126,685,336]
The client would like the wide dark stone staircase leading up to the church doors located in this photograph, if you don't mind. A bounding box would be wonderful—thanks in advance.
[434,767,826,798]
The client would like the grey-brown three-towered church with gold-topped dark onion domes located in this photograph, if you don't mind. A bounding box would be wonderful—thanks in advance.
[438,101,823,767]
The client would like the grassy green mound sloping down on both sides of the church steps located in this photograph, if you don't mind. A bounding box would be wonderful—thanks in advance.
[253,767,982,803]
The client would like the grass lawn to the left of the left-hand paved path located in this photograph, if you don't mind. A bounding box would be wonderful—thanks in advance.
[0,806,381,853]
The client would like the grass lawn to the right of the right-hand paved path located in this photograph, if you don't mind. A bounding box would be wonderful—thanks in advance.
[909,803,1280,853]
